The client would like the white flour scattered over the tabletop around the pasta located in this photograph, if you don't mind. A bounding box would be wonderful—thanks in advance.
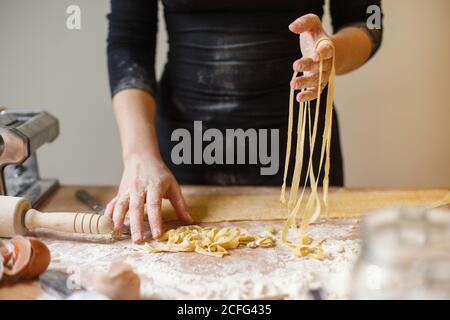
[39,220,360,299]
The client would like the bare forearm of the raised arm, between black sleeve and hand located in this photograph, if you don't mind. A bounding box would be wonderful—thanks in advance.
[331,27,372,74]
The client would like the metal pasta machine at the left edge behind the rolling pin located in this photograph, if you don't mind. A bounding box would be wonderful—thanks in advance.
[0,108,59,207]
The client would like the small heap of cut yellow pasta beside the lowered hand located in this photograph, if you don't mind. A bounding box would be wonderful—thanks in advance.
[146,226,275,258]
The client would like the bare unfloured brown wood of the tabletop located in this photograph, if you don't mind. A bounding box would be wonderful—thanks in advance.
[0,186,450,300]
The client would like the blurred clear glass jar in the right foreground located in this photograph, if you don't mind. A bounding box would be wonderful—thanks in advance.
[350,208,450,299]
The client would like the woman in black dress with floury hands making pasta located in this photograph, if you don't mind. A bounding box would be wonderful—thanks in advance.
[106,0,382,243]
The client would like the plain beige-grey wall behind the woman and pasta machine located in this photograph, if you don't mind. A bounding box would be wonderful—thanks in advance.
[0,0,450,187]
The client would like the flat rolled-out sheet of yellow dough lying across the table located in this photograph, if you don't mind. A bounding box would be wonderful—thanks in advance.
[162,189,450,222]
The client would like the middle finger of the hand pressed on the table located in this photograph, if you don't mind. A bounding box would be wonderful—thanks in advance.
[129,189,145,244]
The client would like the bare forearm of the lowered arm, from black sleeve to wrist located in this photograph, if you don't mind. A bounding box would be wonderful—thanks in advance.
[113,89,161,163]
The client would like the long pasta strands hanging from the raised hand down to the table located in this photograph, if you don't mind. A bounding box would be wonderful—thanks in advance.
[280,38,336,259]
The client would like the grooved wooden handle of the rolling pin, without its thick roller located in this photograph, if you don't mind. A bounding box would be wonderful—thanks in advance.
[25,209,114,234]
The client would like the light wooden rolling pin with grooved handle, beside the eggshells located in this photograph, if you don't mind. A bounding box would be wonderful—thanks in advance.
[0,196,113,237]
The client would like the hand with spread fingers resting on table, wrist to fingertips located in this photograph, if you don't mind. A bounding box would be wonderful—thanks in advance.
[105,154,193,244]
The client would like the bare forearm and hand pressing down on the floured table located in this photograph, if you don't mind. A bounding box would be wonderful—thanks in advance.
[109,89,192,243]
